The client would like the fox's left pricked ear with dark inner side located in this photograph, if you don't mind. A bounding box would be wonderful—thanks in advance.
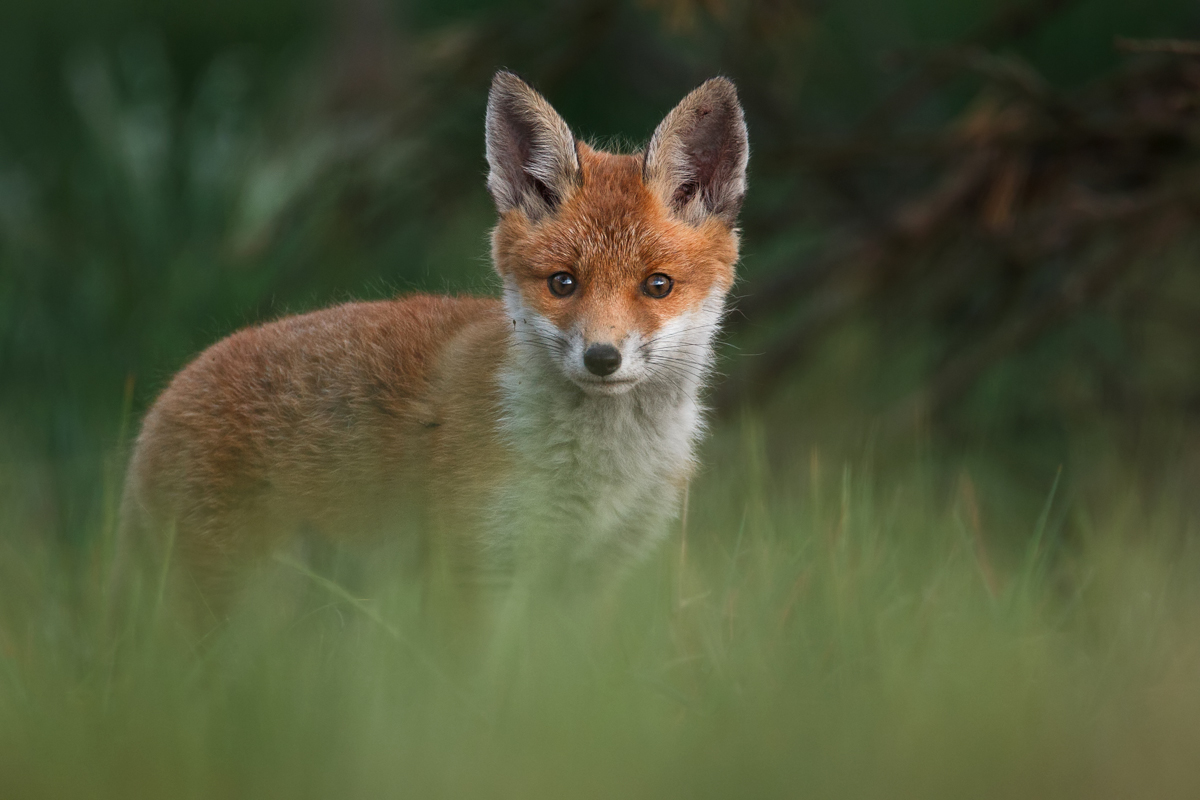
[487,72,580,219]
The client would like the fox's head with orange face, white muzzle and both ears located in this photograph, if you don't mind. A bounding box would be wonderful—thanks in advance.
[487,72,749,395]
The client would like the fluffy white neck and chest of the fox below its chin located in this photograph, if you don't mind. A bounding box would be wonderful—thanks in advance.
[487,291,721,559]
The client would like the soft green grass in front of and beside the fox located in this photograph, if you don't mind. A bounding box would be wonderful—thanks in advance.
[0,417,1200,798]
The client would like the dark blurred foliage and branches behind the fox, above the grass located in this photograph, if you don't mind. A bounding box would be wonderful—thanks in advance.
[0,0,1200,556]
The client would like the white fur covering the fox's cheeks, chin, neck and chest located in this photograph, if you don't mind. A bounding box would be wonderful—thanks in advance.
[484,284,722,573]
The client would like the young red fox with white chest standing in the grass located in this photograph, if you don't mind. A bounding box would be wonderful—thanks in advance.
[122,72,749,606]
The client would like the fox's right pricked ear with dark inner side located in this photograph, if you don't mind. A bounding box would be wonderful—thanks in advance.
[642,78,750,227]
